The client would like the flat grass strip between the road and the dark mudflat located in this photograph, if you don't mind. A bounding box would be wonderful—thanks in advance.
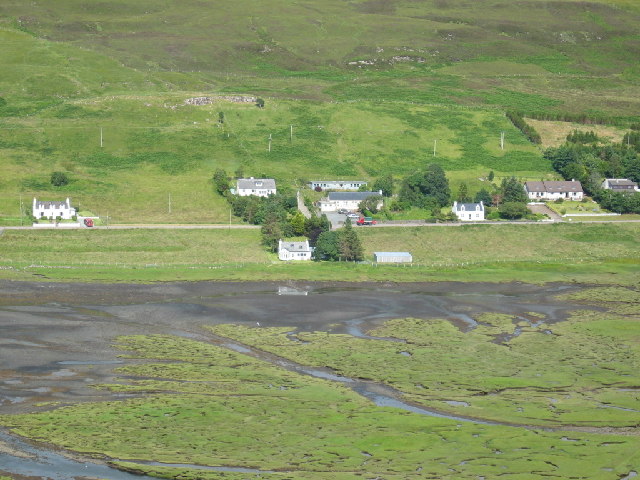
[0,222,640,283]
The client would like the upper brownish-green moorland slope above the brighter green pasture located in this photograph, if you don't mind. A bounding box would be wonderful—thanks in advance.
[0,0,640,116]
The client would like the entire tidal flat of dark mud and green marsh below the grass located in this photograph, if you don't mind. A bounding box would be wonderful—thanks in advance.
[0,282,640,479]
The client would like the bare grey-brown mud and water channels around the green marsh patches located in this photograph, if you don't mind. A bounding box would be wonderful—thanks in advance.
[0,282,584,480]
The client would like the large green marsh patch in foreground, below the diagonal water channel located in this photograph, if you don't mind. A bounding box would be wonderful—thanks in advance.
[0,335,638,480]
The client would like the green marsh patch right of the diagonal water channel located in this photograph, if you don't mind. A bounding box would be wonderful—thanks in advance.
[209,304,640,427]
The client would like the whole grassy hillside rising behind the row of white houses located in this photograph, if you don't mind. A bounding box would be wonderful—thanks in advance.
[0,0,640,224]
